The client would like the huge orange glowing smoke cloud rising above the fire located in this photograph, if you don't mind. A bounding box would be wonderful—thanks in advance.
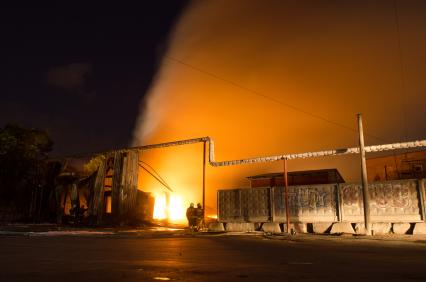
[133,1,426,217]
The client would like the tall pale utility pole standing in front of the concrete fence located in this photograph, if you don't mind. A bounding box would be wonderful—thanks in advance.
[357,114,371,235]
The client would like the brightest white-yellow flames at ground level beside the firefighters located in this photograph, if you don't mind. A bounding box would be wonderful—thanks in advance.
[154,194,186,223]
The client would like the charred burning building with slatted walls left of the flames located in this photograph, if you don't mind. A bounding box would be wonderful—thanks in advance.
[29,150,154,225]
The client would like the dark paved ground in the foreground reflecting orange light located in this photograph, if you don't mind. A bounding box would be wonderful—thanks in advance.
[0,232,426,282]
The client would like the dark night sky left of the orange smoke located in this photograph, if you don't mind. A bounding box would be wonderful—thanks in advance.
[0,1,186,155]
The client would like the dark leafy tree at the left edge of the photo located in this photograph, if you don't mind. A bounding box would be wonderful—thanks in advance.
[0,124,53,207]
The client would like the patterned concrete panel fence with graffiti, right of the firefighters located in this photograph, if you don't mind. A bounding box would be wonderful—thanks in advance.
[217,179,426,223]
